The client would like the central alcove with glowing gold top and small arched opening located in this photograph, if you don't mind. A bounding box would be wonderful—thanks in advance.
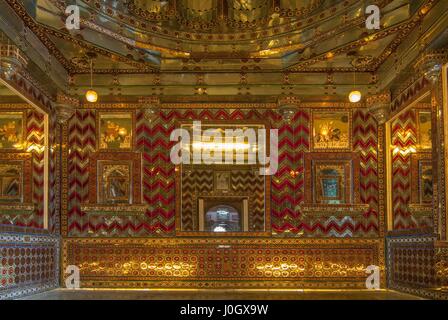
[176,122,271,236]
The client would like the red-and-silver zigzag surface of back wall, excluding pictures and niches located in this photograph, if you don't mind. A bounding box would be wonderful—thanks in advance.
[68,109,380,237]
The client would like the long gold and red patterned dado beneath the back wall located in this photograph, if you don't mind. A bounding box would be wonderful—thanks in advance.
[62,238,384,289]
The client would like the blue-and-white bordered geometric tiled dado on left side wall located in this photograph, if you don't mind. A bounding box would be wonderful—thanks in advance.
[0,233,59,299]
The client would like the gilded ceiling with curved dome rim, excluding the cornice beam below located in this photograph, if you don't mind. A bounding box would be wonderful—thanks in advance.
[8,0,425,72]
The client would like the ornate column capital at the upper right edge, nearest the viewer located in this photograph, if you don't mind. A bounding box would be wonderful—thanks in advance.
[414,50,448,84]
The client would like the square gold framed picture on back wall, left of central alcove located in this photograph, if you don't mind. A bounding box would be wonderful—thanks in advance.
[97,112,134,151]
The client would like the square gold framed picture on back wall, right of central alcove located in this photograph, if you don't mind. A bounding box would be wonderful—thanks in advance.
[312,110,351,151]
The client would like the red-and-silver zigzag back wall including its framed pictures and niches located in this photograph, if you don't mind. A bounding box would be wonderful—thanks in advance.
[63,105,384,237]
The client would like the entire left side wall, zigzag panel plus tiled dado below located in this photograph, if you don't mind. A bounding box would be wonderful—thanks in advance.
[0,103,60,299]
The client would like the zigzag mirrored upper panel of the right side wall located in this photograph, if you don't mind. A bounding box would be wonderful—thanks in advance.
[391,104,434,230]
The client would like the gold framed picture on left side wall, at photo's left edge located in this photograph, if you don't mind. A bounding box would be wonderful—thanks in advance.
[0,112,25,150]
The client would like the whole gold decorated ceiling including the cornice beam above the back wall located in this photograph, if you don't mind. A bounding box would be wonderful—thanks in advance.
[2,0,447,100]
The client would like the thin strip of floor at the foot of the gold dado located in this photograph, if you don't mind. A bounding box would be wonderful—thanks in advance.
[22,289,420,300]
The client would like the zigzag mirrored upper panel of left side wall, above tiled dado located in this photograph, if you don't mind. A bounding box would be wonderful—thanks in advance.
[0,105,49,229]
